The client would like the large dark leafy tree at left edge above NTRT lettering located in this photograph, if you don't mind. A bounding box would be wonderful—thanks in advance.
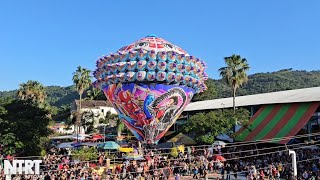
[0,99,51,155]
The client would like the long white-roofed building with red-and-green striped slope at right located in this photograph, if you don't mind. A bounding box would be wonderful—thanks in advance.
[184,87,320,144]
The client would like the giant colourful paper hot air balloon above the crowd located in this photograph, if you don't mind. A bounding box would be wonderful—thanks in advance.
[94,35,207,144]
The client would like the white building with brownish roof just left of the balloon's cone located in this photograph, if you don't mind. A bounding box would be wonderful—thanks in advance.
[71,100,117,127]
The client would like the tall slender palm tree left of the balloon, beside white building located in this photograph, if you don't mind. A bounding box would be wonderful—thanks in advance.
[72,66,91,136]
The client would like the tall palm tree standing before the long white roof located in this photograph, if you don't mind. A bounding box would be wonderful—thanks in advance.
[219,54,250,113]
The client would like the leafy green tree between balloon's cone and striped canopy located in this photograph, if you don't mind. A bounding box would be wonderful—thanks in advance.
[183,108,250,144]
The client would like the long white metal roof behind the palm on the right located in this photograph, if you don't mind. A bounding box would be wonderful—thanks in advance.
[185,87,320,111]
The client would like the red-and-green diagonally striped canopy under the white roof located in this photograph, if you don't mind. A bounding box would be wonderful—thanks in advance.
[236,102,320,144]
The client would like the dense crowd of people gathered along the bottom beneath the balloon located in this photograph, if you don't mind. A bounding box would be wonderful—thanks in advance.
[0,141,320,180]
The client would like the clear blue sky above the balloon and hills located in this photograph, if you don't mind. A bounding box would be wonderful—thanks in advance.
[0,0,320,91]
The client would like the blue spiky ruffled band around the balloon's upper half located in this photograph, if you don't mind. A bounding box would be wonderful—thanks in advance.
[94,49,208,92]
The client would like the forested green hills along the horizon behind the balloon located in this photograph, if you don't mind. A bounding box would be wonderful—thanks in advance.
[0,69,320,107]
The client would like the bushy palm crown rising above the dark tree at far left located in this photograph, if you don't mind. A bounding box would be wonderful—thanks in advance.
[17,80,47,105]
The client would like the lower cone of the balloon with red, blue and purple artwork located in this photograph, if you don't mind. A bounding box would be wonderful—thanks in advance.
[103,83,194,143]
